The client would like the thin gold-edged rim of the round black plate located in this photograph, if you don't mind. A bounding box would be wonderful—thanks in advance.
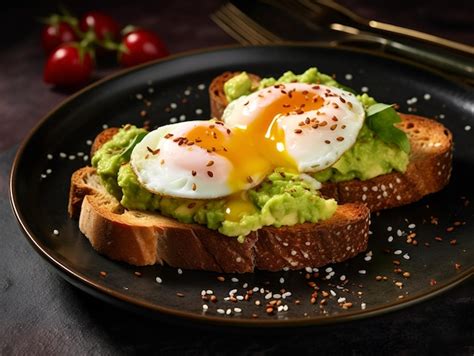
[9,42,474,328]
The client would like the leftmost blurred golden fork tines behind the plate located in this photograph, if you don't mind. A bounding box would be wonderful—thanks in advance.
[211,2,283,45]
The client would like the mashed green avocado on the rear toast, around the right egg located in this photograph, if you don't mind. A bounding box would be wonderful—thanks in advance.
[224,67,409,182]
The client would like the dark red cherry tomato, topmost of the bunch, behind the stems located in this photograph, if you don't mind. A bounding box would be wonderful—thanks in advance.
[79,11,120,41]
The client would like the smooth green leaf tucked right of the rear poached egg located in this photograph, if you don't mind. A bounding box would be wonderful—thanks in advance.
[366,103,410,153]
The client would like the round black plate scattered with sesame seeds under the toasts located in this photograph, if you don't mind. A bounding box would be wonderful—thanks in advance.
[11,46,474,326]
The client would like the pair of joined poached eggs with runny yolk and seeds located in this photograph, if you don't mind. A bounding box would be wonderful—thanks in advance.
[130,83,365,203]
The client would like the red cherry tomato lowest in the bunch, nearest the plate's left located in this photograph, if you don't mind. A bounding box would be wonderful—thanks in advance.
[43,43,94,87]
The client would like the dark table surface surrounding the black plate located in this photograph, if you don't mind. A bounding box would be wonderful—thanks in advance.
[0,0,474,355]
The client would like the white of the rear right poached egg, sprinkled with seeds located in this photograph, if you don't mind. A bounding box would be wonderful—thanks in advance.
[223,83,365,172]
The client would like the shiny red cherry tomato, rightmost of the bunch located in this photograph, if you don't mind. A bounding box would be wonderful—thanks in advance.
[119,29,169,67]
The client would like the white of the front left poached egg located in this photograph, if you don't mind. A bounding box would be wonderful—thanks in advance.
[130,121,237,199]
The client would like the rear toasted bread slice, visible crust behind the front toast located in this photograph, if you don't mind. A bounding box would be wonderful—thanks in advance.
[209,72,453,211]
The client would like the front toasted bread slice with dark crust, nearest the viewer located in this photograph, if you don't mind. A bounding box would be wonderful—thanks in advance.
[69,167,370,273]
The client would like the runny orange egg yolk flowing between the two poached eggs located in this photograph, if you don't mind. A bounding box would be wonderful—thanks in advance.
[185,90,324,221]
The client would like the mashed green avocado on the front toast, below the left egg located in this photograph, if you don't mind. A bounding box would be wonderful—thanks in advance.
[92,126,337,241]
